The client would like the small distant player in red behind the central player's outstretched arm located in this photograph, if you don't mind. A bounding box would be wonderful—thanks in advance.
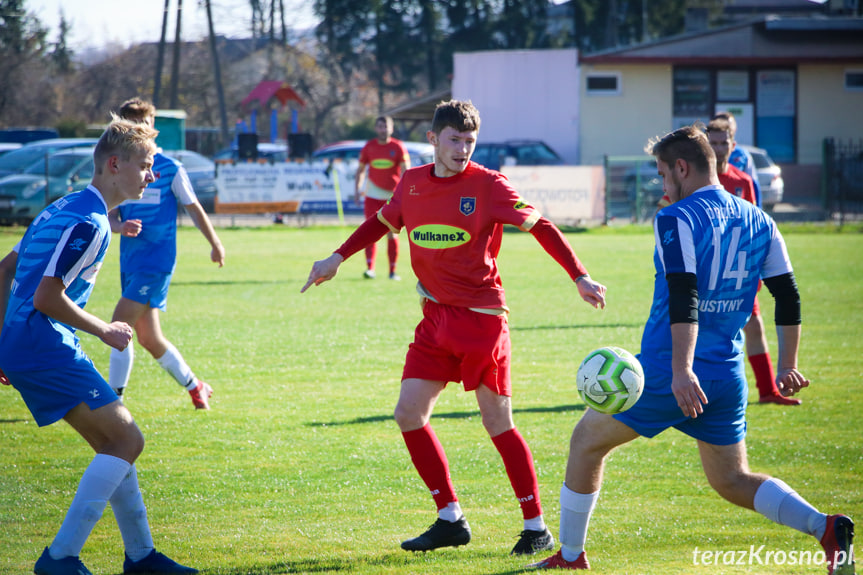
[354,116,411,280]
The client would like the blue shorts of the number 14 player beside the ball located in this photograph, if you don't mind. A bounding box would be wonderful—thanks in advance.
[614,373,748,445]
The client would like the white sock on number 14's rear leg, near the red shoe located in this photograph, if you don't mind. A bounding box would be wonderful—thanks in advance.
[753,477,827,541]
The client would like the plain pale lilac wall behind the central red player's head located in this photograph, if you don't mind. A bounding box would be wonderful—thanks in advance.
[452,49,580,164]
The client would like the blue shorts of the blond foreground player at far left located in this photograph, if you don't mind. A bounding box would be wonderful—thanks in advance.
[5,355,117,427]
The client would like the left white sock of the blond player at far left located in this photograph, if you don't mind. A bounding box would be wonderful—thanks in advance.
[48,453,131,559]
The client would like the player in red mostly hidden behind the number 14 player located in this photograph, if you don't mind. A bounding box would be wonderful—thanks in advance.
[707,117,800,405]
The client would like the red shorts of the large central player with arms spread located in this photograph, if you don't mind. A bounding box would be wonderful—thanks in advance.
[402,300,512,397]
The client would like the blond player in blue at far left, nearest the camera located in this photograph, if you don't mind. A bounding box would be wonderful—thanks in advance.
[0,120,197,575]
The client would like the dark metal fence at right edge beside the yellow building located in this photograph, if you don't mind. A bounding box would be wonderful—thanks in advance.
[822,138,863,222]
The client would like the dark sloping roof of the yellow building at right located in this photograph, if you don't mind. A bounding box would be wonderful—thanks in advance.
[579,16,863,65]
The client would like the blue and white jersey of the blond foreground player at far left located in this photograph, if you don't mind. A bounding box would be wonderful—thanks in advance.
[0,186,111,372]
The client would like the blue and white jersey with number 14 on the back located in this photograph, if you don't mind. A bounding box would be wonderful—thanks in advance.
[639,186,792,380]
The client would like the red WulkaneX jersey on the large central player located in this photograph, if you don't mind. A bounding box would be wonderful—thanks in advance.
[378,162,541,309]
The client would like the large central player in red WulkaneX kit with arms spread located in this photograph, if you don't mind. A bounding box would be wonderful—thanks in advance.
[301,100,605,555]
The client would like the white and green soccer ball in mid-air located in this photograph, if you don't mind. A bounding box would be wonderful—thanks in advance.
[576,347,644,414]
